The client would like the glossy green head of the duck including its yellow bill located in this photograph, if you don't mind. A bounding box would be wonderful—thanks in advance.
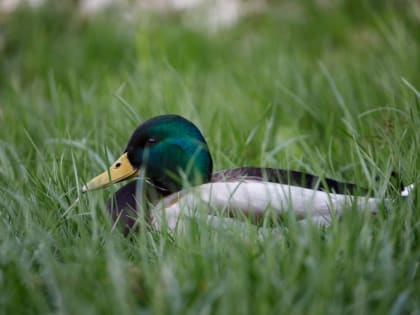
[82,115,213,194]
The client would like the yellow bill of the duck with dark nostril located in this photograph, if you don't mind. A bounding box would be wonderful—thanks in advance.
[82,152,139,193]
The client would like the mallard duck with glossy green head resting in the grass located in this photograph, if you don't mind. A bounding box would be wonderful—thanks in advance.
[82,115,407,233]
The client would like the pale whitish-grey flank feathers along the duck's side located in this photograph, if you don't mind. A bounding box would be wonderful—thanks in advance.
[151,180,392,229]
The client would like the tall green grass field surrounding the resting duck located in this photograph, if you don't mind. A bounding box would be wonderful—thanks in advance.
[0,0,420,315]
